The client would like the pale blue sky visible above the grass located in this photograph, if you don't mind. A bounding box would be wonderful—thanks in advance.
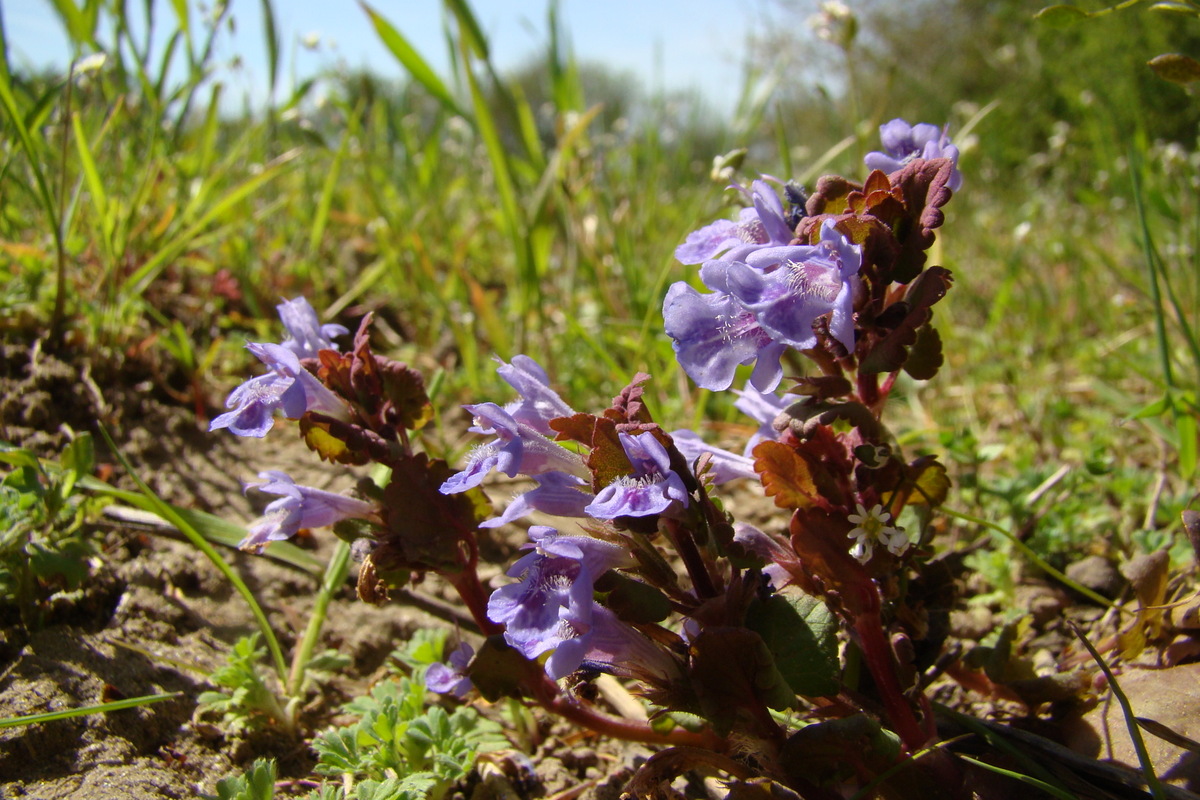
[7,0,787,113]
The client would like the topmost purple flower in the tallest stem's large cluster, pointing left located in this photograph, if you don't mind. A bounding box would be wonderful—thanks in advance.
[676,180,794,264]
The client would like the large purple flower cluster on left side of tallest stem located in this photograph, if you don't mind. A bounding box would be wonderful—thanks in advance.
[662,180,862,392]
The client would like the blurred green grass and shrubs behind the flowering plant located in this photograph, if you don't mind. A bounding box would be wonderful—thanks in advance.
[0,0,1200,563]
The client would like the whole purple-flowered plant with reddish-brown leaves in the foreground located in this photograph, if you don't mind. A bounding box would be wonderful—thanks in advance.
[212,120,967,798]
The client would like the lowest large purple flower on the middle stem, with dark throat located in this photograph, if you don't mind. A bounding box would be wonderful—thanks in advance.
[487,525,631,678]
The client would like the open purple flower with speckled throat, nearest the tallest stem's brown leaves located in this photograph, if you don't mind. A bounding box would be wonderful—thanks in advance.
[726,219,863,351]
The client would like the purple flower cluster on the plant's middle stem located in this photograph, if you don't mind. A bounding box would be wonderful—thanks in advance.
[431,356,690,691]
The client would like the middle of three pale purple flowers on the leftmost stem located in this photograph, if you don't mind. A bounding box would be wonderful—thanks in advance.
[209,342,349,439]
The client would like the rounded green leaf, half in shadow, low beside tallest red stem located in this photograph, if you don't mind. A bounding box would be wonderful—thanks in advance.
[746,593,840,697]
